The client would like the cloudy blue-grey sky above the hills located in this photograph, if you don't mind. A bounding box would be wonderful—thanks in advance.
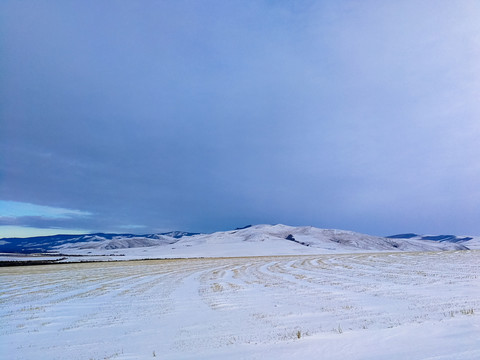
[0,0,480,237]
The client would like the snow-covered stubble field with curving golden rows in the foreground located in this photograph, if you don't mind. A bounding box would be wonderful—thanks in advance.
[0,251,480,360]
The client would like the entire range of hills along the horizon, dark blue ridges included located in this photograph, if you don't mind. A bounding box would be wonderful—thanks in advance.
[0,224,480,257]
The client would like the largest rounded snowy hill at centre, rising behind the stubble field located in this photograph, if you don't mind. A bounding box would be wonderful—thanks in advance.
[152,225,467,256]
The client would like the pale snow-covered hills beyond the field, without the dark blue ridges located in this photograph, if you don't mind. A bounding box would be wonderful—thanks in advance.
[39,225,467,259]
